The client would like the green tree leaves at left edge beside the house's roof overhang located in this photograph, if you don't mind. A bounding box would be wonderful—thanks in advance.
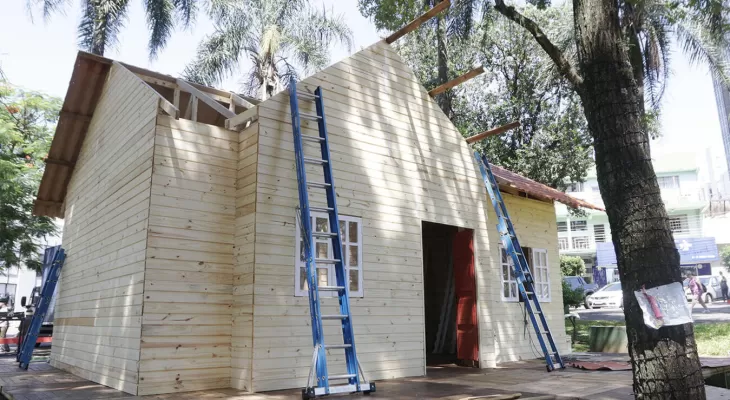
[0,82,61,269]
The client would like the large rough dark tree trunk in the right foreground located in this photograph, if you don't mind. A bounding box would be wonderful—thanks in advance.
[573,0,705,399]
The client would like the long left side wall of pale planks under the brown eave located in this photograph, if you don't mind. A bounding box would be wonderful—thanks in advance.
[51,62,158,394]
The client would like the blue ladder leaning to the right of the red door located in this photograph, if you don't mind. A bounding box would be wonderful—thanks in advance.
[474,151,565,372]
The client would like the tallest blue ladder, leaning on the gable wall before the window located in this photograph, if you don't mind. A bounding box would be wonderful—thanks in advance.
[289,79,375,399]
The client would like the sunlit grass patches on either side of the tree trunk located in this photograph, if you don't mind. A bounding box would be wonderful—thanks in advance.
[565,320,730,357]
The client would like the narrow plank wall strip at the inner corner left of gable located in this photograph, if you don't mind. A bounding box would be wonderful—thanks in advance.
[231,114,259,390]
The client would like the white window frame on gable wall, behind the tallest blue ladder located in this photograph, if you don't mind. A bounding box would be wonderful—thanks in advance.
[294,212,365,297]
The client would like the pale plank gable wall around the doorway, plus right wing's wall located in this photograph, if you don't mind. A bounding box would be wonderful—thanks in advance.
[246,42,567,391]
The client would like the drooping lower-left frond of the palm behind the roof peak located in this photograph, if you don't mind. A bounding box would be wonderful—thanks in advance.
[183,25,246,86]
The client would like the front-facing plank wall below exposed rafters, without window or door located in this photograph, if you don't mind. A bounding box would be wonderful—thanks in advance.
[138,115,239,395]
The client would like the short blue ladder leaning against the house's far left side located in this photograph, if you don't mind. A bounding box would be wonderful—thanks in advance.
[17,246,66,370]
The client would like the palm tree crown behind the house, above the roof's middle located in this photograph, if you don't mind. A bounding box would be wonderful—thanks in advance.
[183,0,352,100]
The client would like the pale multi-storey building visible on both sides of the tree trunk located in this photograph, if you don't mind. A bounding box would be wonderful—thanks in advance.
[556,157,721,284]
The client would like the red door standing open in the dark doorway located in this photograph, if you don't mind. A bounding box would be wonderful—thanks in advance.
[452,229,479,367]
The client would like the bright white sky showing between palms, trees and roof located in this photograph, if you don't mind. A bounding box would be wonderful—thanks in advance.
[0,0,727,183]
